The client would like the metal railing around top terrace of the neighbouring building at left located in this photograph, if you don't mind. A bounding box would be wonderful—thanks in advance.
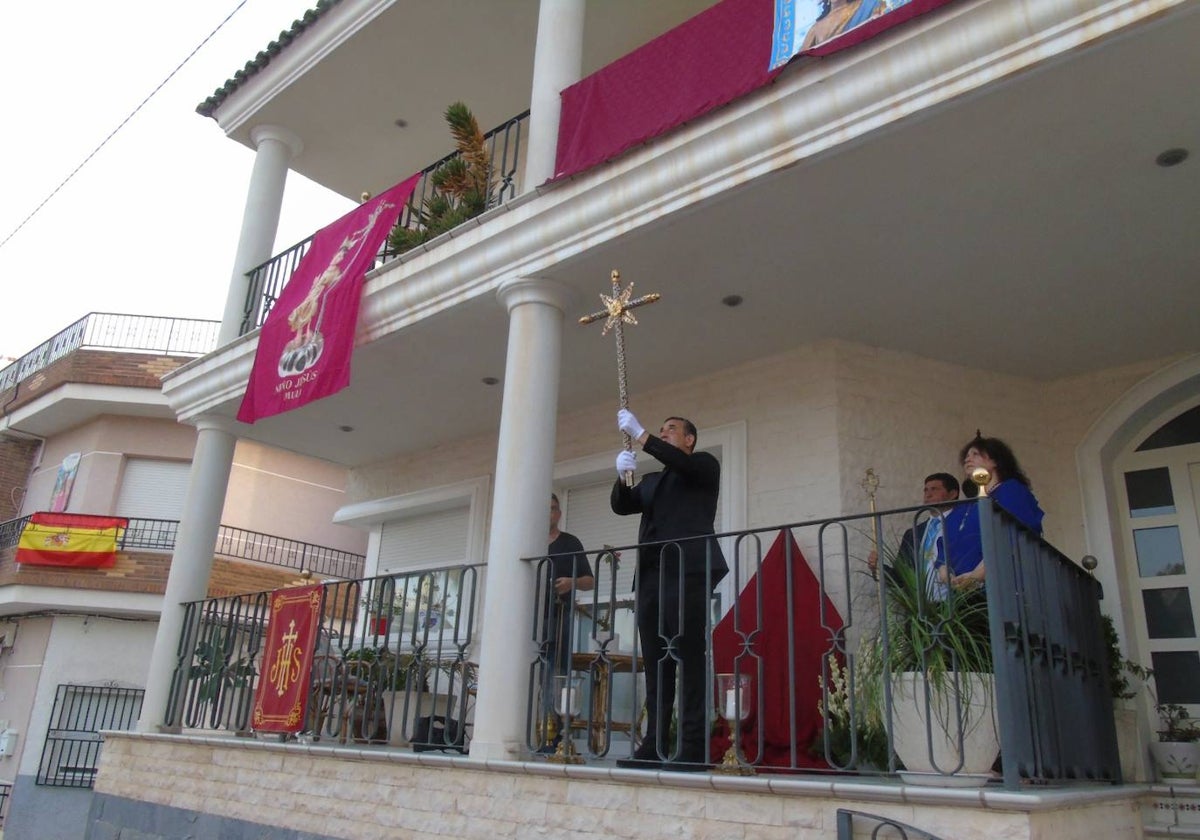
[0,312,221,391]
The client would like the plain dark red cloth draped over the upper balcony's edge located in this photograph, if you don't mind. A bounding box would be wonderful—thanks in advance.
[552,0,952,180]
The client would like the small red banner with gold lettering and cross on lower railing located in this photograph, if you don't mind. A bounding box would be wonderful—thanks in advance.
[253,584,320,732]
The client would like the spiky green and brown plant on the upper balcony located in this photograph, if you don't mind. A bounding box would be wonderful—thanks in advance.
[388,102,492,253]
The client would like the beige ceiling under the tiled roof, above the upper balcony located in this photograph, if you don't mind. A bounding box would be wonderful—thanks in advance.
[216,0,718,200]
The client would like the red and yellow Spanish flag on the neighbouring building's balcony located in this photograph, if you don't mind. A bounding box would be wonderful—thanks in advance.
[17,512,130,569]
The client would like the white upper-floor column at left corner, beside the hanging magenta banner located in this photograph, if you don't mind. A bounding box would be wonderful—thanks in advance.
[217,126,304,346]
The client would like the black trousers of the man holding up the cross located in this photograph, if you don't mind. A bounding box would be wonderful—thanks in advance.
[637,570,708,762]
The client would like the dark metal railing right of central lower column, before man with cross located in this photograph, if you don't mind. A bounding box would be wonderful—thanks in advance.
[527,499,1121,790]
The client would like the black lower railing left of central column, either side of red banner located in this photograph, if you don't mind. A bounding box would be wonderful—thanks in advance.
[164,565,481,750]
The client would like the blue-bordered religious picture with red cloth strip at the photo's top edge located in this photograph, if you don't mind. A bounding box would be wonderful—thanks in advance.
[769,0,950,70]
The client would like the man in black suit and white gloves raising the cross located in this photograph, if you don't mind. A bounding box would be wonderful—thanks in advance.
[611,409,728,770]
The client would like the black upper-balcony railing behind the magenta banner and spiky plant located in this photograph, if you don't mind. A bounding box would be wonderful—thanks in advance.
[238,110,529,335]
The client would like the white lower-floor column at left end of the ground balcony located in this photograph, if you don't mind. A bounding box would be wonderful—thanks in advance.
[138,418,238,732]
